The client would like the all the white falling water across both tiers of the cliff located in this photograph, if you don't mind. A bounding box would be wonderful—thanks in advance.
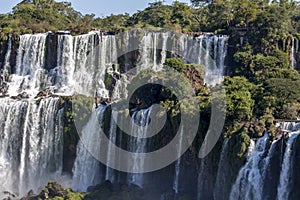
[0,31,299,200]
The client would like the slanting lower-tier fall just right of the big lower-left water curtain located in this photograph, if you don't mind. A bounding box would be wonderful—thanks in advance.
[72,105,106,192]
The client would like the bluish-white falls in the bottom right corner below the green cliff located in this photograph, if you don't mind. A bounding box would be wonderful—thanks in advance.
[230,122,300,200]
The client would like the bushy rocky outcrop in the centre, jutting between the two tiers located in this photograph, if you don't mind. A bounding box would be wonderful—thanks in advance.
[127,58,204,116]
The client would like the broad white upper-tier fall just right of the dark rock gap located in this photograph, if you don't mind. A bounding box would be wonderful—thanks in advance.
[54,31,112,96]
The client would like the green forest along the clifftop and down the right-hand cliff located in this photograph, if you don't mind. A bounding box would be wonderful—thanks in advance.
[0,0,300,198]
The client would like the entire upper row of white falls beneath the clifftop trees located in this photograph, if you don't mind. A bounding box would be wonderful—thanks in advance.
[5,31,228,97]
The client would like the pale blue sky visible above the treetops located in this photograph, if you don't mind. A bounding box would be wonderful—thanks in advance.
[0,0,189,17]
